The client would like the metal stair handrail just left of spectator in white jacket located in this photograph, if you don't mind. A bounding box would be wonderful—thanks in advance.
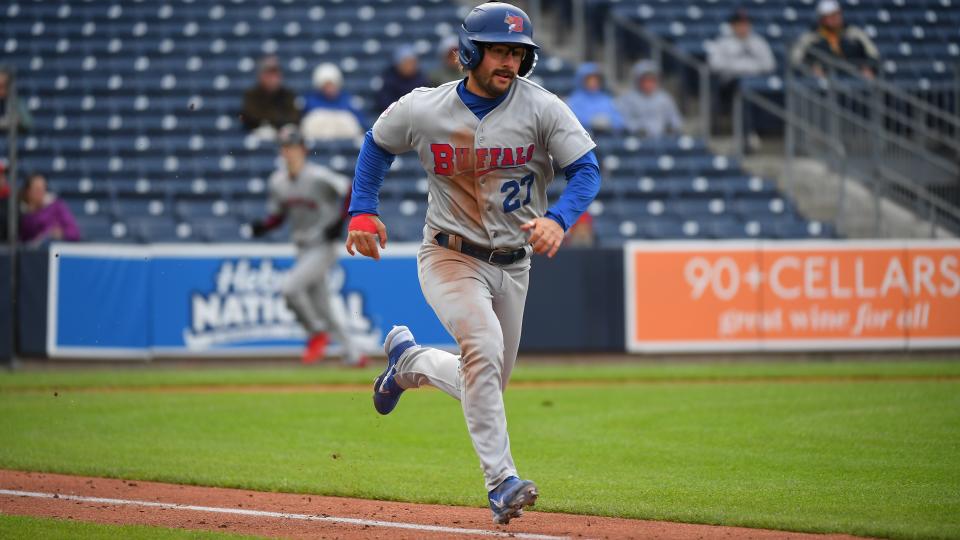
[603,12,712,139]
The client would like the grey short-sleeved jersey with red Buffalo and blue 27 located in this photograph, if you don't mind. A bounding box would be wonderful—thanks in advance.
[373,78,596,248]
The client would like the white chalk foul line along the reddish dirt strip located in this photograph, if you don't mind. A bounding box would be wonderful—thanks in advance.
[0,489,566,540]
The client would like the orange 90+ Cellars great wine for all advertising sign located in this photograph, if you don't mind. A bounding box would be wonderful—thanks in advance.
[624,241,960,352]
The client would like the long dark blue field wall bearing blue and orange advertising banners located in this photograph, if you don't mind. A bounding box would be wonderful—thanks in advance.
[9,241,960,360]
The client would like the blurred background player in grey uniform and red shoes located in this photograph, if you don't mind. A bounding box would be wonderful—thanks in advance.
[251,124,366,366]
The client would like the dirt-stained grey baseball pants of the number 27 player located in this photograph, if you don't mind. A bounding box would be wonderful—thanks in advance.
[395,243,530,491]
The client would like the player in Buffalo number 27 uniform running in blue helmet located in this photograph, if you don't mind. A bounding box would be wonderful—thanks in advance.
[346,2,600,524]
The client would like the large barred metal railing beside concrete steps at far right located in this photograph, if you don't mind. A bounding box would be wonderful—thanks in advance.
[780,51,960,236]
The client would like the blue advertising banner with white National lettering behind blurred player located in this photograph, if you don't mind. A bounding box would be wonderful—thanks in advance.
[47,244,455,359]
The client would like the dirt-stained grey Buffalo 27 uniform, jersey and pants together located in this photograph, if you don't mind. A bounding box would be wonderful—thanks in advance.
[373,78,595,490]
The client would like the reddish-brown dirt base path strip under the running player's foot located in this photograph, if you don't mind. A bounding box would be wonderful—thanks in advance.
[0,470,853,540]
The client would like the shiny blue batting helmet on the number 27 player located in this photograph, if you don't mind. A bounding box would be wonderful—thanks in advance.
[460,2,540,77]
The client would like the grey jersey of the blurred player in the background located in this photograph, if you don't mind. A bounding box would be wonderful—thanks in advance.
[268,161,350,246]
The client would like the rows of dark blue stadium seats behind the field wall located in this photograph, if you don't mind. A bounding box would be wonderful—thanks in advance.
[0,0,836,244]
